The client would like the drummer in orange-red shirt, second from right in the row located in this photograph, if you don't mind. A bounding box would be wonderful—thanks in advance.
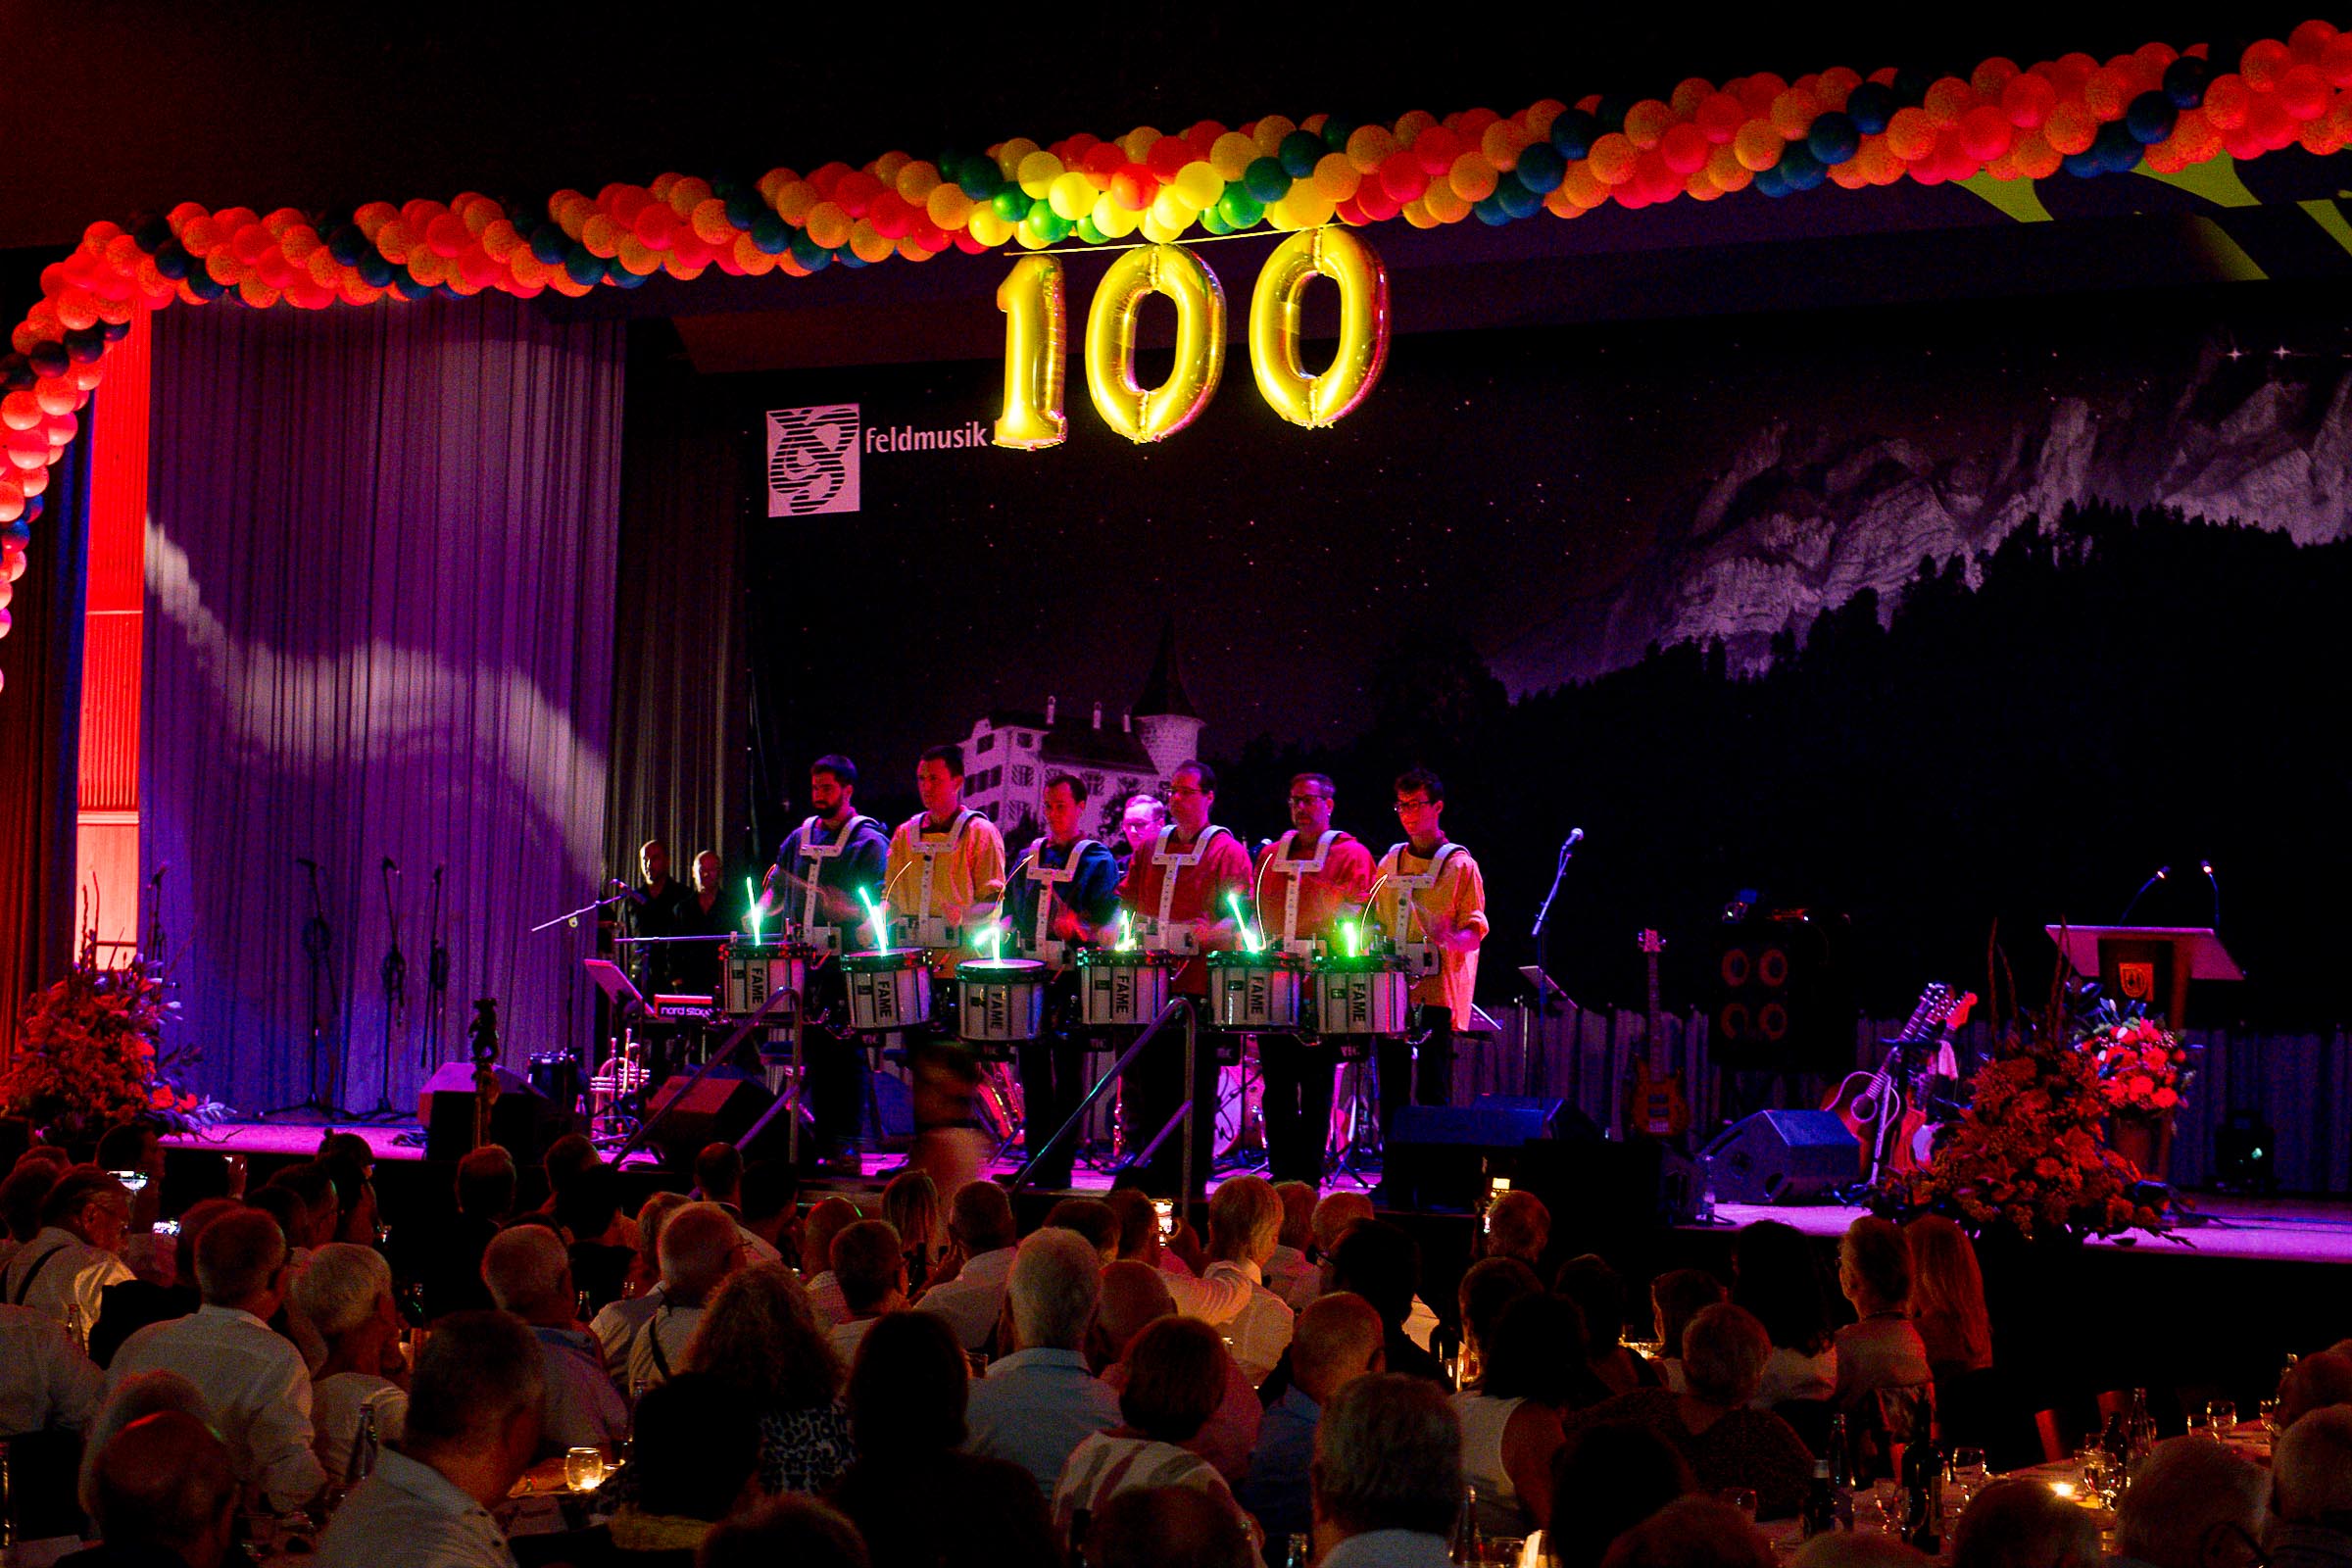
[1256,773,1371,1183]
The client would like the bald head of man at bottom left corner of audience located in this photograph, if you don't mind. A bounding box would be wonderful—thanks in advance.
[61,1410,237,1568]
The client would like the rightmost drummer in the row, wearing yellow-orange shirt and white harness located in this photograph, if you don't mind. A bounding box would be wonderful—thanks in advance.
[1371,768,1487,1145]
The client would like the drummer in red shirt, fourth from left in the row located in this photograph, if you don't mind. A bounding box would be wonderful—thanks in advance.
[1119,761,1249,1197]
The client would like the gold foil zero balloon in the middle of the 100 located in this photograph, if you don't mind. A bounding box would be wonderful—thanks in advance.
[1087,244,1225,442]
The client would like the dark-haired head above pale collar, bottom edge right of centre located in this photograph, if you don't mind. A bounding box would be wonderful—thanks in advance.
[1312,1373,1463,1568]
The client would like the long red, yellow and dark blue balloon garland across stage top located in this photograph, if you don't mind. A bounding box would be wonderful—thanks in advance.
[0,22,2352,681]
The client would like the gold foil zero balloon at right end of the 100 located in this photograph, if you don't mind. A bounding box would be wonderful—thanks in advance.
[1249,228,1388,430]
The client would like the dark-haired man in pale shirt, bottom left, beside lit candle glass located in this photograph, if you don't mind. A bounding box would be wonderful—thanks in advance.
[316,1316,543,1568]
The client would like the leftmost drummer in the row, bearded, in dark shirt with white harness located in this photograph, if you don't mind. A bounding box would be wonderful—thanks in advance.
[748,755,889,1166]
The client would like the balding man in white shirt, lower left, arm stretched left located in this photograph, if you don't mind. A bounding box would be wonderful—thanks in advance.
[108,1208,327,1511]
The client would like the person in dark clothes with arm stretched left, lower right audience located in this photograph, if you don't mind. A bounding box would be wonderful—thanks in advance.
[1566,1302,1813,1519]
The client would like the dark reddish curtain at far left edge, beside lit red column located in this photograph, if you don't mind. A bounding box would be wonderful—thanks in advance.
[0,442,89,1062]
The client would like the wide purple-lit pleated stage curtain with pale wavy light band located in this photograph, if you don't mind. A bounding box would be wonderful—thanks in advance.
[141,296,623,1114]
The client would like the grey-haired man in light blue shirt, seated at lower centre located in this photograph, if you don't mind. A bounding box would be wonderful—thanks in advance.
[955,1222,1119,1499]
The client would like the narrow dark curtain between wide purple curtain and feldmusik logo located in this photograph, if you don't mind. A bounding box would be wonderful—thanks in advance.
[607,322,748,903]
